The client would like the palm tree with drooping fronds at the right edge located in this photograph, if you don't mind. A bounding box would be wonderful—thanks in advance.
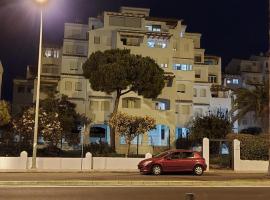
[231,84,269,133]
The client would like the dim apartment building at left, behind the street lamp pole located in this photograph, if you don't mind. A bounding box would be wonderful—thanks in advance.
[12,44,62,115]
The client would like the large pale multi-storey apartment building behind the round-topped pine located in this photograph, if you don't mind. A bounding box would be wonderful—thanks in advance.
[59,7,234,153]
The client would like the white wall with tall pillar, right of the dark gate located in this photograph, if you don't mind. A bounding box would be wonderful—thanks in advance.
[233,139,269,172]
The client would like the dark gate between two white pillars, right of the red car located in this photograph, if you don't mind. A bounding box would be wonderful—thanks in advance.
[209,139,233,169]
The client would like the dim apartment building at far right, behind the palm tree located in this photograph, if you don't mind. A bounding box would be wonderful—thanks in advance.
[224,54,269,131]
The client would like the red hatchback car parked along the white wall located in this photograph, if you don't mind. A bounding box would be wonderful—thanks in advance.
[138,150,207,175]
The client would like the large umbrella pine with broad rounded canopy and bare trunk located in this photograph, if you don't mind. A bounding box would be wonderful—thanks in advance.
[83,49,165,148]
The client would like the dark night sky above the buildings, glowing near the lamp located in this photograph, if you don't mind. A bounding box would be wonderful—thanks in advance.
[0,0,268,100]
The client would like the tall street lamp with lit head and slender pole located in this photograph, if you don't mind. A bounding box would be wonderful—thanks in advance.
[31,0,48,169]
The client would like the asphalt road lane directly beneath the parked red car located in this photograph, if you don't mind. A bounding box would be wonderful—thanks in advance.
[0,172,270,181]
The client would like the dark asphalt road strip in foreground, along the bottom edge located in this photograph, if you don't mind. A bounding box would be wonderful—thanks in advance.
[0,187,270,200]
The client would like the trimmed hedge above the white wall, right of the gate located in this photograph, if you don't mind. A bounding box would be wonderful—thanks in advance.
[227,134,269,160]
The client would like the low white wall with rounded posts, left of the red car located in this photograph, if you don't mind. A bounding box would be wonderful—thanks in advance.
[0,152,152,171]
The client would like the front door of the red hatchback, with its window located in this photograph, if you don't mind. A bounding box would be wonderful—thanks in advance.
[163,152,180,172]
